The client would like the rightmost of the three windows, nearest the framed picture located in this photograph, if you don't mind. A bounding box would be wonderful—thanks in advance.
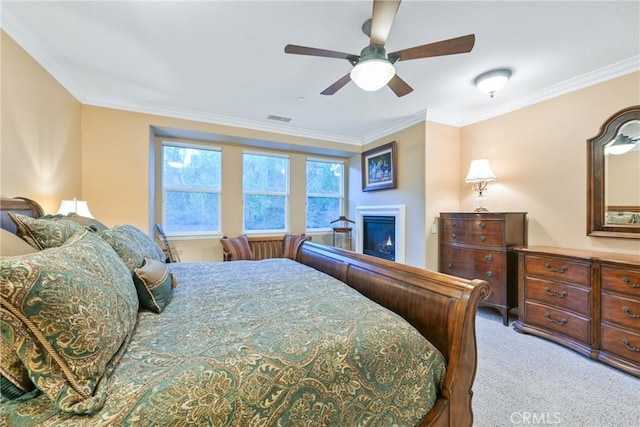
[307,158,344,229]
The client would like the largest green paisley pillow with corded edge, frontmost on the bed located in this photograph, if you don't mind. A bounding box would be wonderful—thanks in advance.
[0,229,138,414]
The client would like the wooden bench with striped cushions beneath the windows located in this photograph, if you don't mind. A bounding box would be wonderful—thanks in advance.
[220,234,311,261]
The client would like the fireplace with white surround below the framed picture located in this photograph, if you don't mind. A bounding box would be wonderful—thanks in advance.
[355,205,406,263]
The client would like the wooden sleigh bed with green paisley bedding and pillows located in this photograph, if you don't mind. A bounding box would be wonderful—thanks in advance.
[0,199,488,427]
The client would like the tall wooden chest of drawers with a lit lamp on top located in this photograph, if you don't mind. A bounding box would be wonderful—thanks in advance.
[438,212,527,326]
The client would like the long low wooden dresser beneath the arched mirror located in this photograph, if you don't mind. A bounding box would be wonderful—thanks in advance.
[514,246,640,376]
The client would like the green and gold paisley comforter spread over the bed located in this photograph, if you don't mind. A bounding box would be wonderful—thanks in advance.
[0,259,445,427]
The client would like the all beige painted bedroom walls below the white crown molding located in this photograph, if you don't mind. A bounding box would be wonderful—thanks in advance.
[5,31,640,269]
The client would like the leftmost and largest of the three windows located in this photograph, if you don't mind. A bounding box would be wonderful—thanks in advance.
[162,141,222,235]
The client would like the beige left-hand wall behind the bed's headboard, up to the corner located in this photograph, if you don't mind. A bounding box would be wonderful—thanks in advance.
[0,30,83,212]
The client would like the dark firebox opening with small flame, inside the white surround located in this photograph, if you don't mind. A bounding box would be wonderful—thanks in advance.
[362,215,396,261]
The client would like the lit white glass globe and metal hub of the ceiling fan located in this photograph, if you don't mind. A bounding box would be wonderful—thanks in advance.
[350,44,396,92]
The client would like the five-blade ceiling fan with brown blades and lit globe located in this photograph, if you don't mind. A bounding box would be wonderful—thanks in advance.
[284,0,476,97]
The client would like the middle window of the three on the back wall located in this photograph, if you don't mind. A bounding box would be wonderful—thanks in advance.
[242,151,289,232]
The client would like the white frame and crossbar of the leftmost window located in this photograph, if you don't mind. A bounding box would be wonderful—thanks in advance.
[158,138,224,240]
